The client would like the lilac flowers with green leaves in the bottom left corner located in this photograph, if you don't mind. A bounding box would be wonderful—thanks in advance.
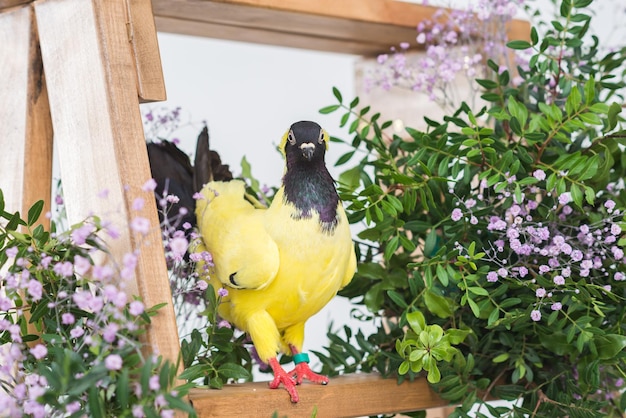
[0,183,191,417]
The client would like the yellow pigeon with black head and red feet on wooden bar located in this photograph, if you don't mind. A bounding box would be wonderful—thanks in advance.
[196,121,356,402]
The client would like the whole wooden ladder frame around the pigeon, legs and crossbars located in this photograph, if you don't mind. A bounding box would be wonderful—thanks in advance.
[0,0,528,417]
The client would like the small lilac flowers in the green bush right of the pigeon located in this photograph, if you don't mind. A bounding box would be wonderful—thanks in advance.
[451,169,626,321]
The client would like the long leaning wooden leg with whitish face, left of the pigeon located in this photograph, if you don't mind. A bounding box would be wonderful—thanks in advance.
[35,0,180,363]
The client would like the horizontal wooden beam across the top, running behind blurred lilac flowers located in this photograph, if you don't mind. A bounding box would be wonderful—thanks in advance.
[152,0,530,56]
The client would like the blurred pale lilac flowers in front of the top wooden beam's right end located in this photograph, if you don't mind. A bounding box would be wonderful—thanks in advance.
[366,0,527,108]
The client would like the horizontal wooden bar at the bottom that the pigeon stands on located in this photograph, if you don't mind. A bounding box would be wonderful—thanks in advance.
[189,374,448,418]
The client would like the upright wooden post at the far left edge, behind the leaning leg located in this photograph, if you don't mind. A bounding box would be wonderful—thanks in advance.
[0,6,52,225]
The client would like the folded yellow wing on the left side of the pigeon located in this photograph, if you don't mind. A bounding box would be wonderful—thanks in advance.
[196,180,280,289]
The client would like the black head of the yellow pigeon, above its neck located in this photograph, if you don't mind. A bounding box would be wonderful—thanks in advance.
[280,121,328,163]
